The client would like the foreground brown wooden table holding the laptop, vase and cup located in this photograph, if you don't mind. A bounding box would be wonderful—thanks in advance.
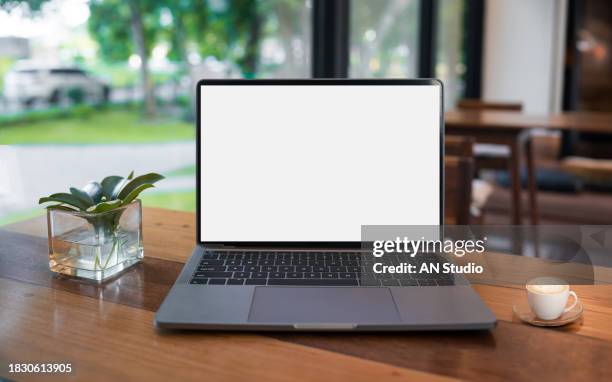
[0,209,612,382]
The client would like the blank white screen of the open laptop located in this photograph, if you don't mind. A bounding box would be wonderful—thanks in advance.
[199,84,441,242]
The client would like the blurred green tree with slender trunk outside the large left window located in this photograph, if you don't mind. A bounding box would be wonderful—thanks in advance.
[0,0,268,116]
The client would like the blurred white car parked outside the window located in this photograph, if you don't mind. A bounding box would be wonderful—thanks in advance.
[3,62,110,106]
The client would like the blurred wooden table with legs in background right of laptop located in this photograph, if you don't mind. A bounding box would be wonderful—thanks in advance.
[445,110,612,224]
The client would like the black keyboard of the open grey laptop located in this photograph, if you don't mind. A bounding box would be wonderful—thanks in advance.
[190,250,454,287]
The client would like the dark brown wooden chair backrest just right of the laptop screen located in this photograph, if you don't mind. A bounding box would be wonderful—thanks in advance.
[444,136,474,224]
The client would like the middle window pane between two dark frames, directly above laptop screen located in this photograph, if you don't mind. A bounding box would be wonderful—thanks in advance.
[349,0,419,77]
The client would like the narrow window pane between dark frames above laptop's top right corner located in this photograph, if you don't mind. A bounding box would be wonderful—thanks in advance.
[435,0,466,109]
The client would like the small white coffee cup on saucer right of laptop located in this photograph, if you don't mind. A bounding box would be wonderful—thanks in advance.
[526,277,578,320]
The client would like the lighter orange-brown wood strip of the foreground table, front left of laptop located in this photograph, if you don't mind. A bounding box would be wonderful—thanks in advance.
[0,278,450,381]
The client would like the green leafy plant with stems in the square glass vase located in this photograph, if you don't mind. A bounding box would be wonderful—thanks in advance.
[38,171,164,270]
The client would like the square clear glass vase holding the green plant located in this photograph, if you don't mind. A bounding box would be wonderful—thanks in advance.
[47,200,143,282]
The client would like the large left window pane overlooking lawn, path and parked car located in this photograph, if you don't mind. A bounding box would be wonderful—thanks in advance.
[0,0,312,226]
